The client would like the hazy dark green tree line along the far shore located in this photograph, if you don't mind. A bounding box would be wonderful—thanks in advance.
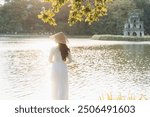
[0,0,150,35]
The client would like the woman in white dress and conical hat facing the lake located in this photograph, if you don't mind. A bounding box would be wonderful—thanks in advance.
[49,32,72,100]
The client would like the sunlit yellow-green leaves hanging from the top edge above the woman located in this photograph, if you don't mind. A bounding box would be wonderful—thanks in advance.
[38,0,112,26]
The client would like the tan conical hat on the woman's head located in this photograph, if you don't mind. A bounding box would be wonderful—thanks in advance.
[50,32,68,44]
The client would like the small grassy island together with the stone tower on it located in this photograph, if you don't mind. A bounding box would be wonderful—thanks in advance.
[92,9,150,41]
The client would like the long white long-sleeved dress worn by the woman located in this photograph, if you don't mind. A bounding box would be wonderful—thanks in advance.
[49,47,71,100]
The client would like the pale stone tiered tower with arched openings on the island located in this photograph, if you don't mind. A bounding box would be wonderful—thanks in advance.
[124,11,144,36]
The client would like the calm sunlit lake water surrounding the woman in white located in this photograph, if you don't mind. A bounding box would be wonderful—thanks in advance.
[0,38,150,99]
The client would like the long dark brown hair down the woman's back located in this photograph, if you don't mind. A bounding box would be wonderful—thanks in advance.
[58,43,70,61]
